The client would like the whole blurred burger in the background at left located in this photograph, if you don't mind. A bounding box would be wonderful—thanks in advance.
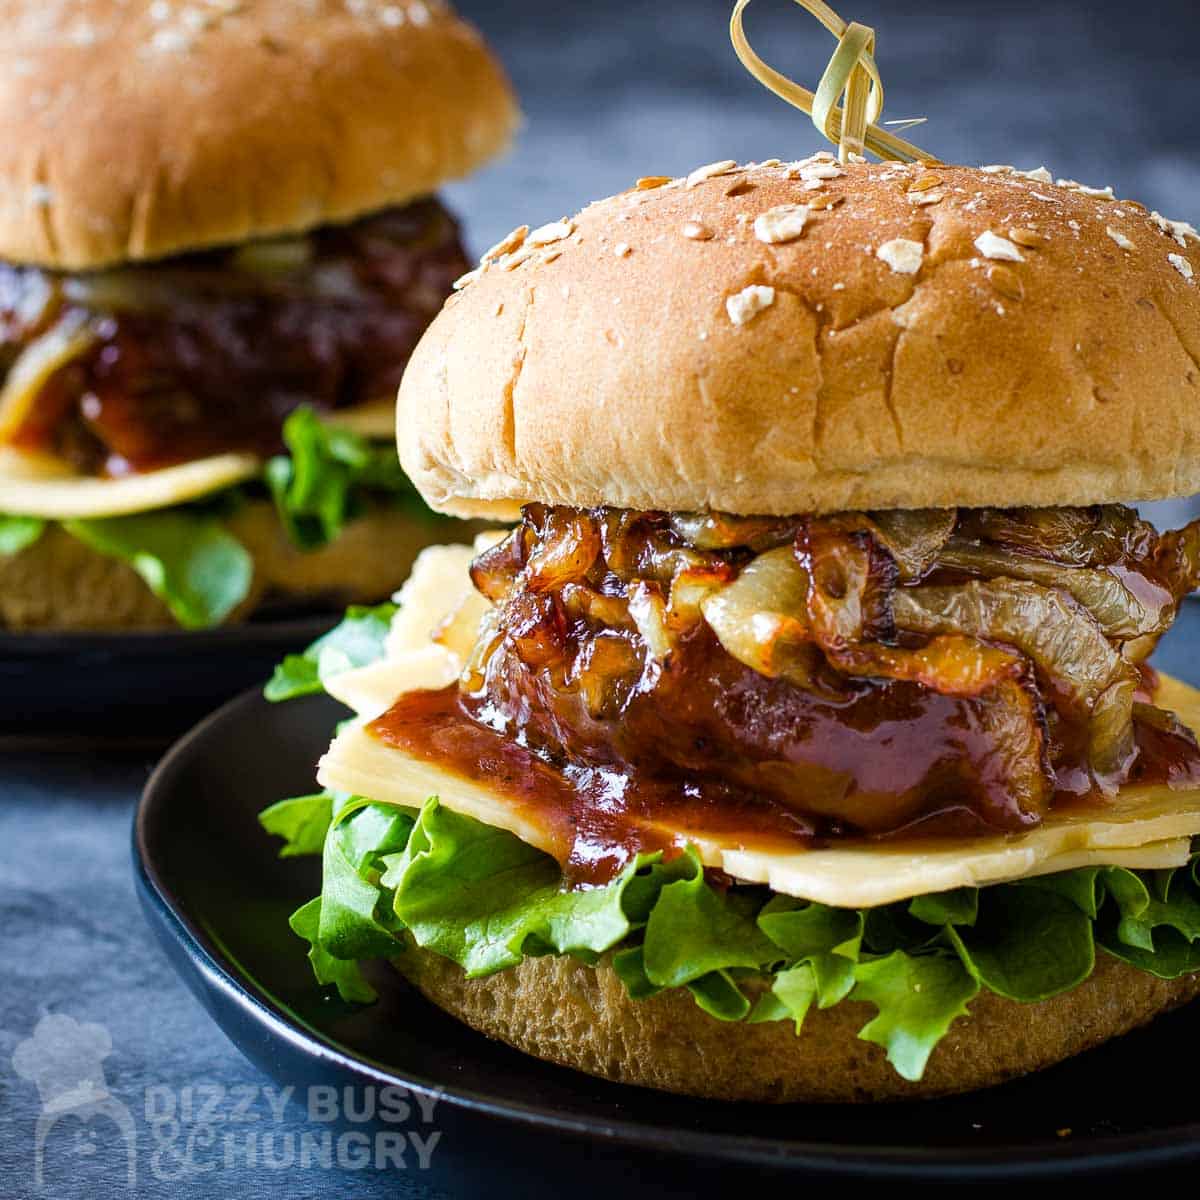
[0,0,517,631]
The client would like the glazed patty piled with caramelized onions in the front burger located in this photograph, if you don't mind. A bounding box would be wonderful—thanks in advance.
[446,496,1200,854]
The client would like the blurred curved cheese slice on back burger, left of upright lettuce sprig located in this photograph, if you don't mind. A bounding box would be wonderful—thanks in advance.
[0,448,263,521]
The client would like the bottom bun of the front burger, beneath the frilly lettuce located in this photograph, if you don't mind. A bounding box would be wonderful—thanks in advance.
[395,947,1200,1104]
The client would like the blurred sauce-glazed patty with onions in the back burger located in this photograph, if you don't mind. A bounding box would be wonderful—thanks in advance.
[0,199,468,475]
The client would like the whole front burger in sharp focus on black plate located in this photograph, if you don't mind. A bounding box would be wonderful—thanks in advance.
[264,155,1200,1102]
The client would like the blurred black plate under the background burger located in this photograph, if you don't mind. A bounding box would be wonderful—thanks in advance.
[0,612,340,745]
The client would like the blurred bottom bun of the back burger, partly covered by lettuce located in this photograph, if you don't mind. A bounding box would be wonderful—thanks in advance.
[0,500,456,632]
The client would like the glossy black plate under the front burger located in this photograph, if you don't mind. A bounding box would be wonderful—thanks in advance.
[134,694,1200,1200]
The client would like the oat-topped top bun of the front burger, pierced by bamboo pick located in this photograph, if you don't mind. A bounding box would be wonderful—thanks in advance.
[398,155,1200,517]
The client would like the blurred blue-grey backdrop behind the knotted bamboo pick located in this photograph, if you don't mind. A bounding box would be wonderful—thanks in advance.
[448,0,1200,250]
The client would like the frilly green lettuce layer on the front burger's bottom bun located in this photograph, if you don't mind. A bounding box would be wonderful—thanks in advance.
[262,797,1200,1079]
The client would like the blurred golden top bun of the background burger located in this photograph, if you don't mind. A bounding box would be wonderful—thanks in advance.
[0,0,518,270]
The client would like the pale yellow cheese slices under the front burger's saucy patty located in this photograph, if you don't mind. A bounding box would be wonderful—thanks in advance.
[318,546,1200,907]
